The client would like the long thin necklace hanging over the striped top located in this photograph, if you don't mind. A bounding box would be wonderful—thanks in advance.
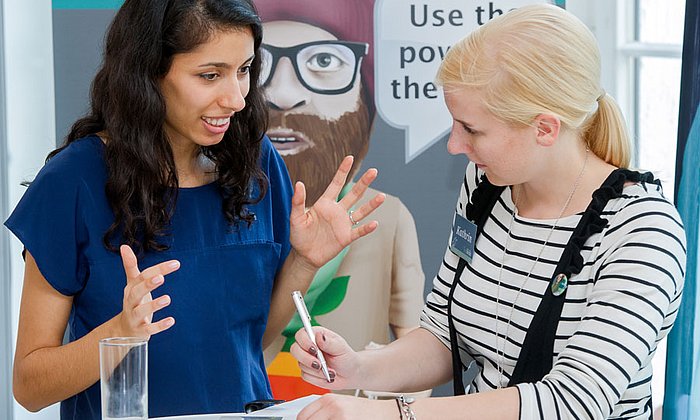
[496,147,588,388]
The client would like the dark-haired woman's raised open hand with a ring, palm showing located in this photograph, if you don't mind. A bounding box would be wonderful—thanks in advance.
[290,156,385,269]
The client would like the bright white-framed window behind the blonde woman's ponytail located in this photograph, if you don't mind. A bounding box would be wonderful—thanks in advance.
[592,0,686,418]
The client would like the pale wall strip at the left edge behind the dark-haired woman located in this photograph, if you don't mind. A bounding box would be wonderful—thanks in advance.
[0,0,58,420]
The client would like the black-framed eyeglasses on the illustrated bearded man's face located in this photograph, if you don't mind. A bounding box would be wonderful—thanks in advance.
[260,41,369,95]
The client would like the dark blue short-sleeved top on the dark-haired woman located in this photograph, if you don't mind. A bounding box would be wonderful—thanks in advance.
[5,136,293,420]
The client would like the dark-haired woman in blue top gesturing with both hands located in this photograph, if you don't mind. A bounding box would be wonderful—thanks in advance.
[6,0,383,420]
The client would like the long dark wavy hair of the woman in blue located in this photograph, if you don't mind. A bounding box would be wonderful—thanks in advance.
[47,0,268,252]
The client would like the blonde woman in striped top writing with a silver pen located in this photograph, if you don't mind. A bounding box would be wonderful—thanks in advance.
[292,5,686,420]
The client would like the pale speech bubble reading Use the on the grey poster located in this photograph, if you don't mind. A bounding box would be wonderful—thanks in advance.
[374,0,562,163]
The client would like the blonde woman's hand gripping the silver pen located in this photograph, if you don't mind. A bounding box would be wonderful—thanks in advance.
[289,327,361,390]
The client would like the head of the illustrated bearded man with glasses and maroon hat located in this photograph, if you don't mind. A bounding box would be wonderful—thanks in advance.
[256,0,374,203]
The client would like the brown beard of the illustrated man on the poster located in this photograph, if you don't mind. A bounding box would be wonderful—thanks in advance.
[269,100,370,203]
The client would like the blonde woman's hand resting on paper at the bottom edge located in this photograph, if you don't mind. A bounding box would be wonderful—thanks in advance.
[297,394,399,420]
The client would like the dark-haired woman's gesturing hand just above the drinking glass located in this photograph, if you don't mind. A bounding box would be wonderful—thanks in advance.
[118,245,180,338]
